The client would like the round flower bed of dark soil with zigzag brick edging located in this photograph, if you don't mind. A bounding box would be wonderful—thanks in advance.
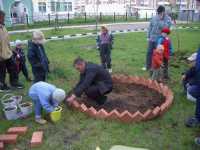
[68,75,173,122]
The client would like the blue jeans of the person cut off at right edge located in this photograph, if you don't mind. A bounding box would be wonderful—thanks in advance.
[187,85,200,121]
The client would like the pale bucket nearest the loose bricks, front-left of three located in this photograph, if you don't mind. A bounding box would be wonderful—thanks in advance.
[3,106,18,120]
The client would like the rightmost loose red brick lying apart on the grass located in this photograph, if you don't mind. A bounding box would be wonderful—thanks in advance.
[31,131,43,147]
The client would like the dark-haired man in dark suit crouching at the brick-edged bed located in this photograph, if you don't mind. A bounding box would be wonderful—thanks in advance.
[67,57,113,105]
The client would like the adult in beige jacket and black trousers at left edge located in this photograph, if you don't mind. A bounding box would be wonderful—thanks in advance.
[0,10,23,92]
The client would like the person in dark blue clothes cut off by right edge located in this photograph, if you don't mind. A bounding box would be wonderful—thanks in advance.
[182,47,200,145]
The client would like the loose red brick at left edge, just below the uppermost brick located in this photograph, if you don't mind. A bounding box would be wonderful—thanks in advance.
[0,134,18,144]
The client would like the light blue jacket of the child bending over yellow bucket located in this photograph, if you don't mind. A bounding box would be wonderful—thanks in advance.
[29,81,58,113]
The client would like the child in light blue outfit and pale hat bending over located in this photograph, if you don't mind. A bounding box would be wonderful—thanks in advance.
[29,81,66,124]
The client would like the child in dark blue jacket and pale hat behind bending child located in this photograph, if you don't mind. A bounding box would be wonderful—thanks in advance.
[28,31,49,83]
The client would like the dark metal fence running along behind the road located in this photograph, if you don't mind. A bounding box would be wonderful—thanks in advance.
[6,10,200,27]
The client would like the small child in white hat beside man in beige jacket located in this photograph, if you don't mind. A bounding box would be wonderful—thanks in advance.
[13,40,31,81]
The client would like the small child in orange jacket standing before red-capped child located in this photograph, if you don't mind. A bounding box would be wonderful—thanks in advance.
[151,45,164,81]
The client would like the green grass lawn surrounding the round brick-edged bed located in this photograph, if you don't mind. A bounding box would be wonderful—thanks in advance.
[0,26,200,150]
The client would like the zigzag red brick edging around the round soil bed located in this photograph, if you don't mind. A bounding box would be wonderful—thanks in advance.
[67,75,174,123]
